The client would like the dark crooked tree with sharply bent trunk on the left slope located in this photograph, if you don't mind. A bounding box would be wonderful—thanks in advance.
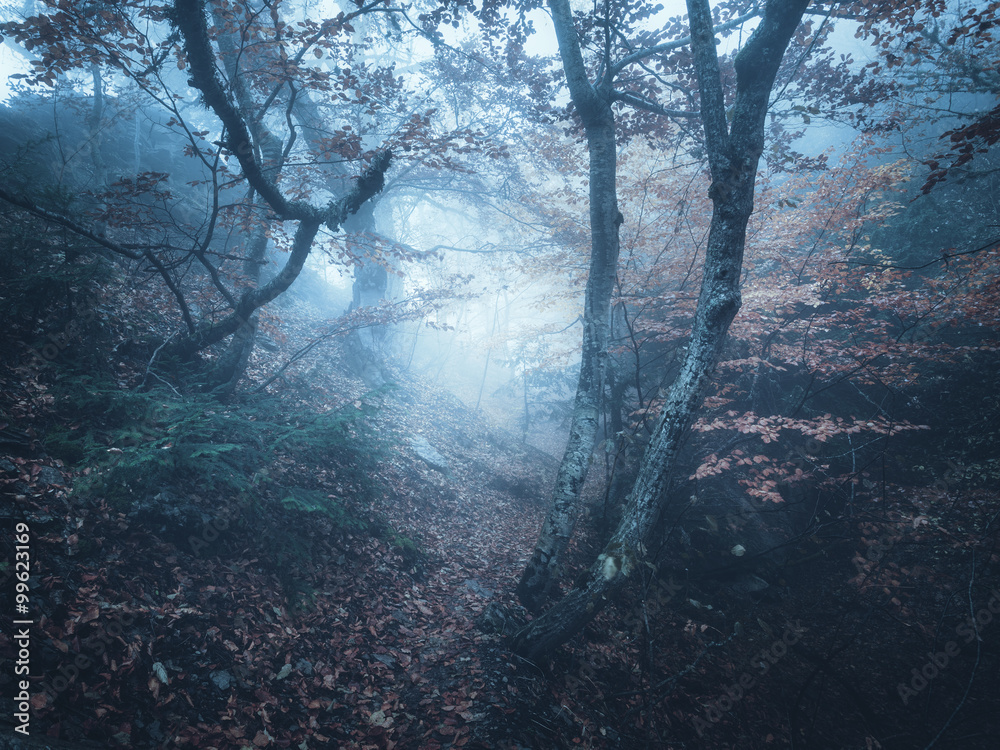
[0,0,392,392]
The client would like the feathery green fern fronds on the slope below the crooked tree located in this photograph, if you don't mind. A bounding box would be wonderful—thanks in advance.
[46,378,381,506]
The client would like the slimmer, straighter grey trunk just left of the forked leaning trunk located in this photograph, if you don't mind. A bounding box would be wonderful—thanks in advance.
[517,0,622,612]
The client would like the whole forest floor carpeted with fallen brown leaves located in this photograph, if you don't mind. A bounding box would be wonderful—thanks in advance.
[0,296,1000,750]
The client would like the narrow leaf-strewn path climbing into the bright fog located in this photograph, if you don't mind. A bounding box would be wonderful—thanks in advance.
[304,384,554,750]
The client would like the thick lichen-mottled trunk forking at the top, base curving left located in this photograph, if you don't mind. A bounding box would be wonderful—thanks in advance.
[514,0,808,659]
